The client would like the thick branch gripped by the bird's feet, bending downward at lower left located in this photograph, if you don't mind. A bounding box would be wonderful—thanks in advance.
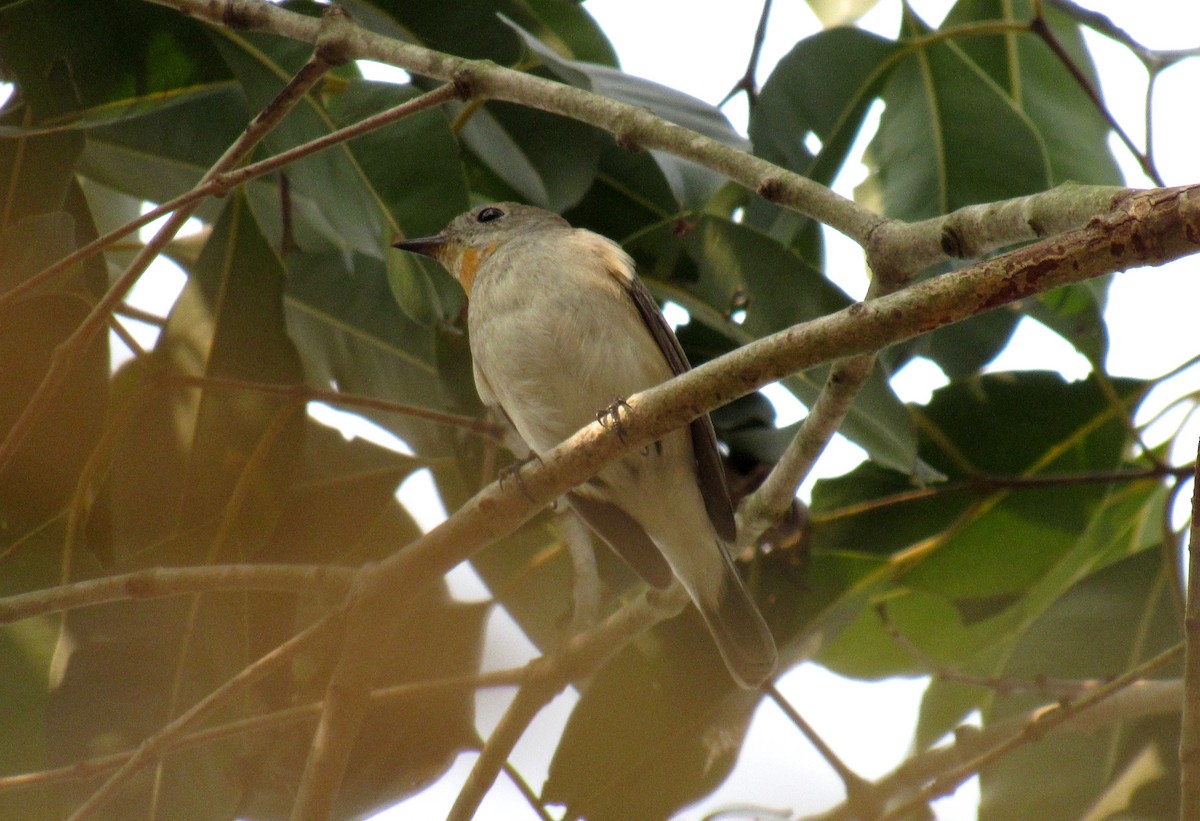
[285,186,1200,819]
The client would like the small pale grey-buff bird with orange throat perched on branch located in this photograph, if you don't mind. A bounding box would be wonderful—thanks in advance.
[395,203,778,688]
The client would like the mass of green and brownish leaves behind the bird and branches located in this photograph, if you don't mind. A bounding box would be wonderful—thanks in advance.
[0,0,1195,817]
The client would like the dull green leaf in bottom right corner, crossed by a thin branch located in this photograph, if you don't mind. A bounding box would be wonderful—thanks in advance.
[979,550,1182,821]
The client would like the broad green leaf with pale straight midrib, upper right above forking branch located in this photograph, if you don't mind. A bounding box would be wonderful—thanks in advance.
[869,10,1054,221]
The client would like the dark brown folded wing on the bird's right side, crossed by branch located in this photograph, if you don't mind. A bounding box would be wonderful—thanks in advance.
[610,264,737,543]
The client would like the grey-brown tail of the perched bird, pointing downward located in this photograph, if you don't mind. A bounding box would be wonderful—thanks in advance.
[695,546,779,689]
